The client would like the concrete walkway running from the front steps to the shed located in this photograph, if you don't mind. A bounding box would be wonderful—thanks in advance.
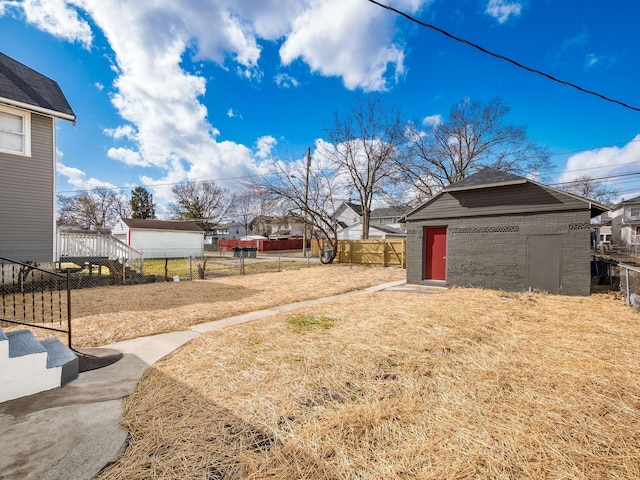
[0,280,406,480]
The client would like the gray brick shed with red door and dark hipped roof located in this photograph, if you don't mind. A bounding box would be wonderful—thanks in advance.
[405,168,607,295]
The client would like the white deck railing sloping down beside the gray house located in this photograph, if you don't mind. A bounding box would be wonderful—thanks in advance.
[56,231,144,273]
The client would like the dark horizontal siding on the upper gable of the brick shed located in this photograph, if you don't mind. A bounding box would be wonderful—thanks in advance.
[410,183,585,221]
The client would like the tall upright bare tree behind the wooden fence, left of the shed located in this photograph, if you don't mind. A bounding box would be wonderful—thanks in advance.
[321,97,405,239]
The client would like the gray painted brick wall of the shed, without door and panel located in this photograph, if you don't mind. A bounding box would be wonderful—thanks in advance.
[407,209,591,295]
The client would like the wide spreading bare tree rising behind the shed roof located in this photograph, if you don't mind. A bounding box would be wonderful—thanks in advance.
[398,98,550,198]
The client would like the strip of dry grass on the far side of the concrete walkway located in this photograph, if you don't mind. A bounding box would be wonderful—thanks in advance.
[65,265,405,348]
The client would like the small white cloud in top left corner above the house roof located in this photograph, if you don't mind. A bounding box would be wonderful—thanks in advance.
[13,0,93,48]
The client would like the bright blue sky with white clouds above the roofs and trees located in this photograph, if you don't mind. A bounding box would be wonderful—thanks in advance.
[0,0,640,214]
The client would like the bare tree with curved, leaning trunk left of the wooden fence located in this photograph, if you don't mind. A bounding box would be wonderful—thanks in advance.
[249,160,339,263]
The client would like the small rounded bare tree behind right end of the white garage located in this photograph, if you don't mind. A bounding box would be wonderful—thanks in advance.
[169,181,233,231]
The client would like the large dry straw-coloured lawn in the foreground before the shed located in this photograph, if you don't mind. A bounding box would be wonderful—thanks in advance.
[100,289,640,480]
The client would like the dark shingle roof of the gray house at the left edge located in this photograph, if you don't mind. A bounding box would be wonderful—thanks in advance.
[0,52,76,122]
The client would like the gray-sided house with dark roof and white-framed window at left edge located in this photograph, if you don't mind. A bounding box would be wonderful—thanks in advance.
[0,53,76,262]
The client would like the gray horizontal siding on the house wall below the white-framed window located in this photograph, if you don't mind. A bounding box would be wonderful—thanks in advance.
[0,113,55,262]
